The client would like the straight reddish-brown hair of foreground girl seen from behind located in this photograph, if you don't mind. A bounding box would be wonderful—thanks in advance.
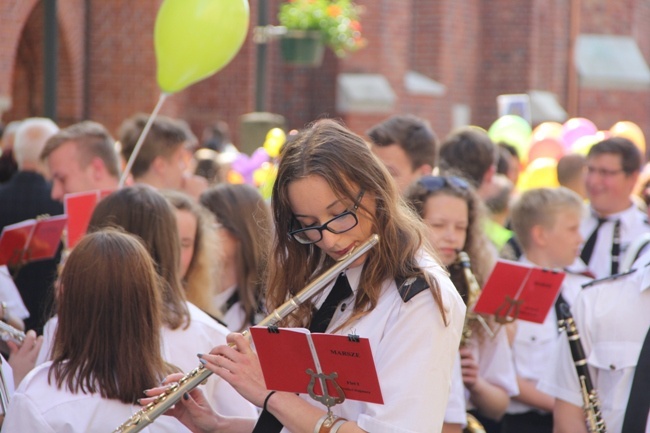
[49,229,169,404]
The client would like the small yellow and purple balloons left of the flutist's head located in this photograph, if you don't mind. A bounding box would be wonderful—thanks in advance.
[227,128,287,199]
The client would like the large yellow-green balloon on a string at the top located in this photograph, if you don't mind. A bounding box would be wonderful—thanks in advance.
[154,0,250,93]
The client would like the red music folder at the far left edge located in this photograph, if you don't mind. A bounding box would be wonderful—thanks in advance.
[0,215,68,266]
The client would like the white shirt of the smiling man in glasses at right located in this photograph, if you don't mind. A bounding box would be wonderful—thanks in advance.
[580,204,650,278]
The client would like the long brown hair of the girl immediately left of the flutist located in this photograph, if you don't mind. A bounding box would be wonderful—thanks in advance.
[200,184,272,330]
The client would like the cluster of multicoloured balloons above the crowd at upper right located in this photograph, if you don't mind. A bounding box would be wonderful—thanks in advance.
[488,115,646,190]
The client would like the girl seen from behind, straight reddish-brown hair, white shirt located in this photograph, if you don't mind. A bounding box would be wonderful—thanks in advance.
[3,230,185,433]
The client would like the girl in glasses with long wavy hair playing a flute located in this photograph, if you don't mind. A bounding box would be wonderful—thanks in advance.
[149,120,465,433]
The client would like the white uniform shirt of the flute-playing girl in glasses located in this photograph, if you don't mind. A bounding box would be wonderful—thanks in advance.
[282,253,465,433]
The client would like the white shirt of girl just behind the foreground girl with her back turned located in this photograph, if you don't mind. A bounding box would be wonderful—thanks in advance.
[36,302,258,418]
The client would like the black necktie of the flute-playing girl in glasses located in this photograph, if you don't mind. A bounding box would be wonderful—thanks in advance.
[253,273,352,433]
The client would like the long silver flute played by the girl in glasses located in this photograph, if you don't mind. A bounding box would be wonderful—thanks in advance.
[113,234,379,433]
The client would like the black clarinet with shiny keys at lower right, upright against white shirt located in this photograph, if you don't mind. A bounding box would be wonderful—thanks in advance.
[558,303,607,433]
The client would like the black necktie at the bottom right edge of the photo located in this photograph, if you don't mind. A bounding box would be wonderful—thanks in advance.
[621,329,650,433]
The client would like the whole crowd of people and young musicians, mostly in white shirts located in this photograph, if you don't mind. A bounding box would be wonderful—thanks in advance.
[0,114,650,433]
